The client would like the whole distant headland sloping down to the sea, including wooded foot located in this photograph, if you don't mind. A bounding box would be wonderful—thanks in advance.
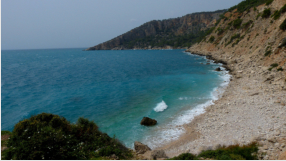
[86,10,225,50]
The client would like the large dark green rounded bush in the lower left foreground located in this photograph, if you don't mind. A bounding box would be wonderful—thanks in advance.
[2,113,131,160]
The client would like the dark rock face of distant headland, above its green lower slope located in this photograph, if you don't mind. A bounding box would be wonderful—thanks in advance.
[87,10,225,50]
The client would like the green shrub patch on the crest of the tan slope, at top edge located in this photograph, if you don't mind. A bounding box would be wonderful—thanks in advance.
[228,0,273,13]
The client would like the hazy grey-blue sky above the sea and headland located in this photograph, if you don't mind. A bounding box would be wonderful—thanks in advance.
[1,0,242,50]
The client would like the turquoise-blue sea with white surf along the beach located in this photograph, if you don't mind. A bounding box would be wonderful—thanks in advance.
[1,49,229,148]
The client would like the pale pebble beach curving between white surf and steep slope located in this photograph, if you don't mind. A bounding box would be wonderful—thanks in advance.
[150,47,286,157]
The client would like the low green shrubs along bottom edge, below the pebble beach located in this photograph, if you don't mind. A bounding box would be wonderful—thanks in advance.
[170,143,258,160]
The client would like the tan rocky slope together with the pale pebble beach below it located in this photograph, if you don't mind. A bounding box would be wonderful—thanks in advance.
[159,0,286,160]
